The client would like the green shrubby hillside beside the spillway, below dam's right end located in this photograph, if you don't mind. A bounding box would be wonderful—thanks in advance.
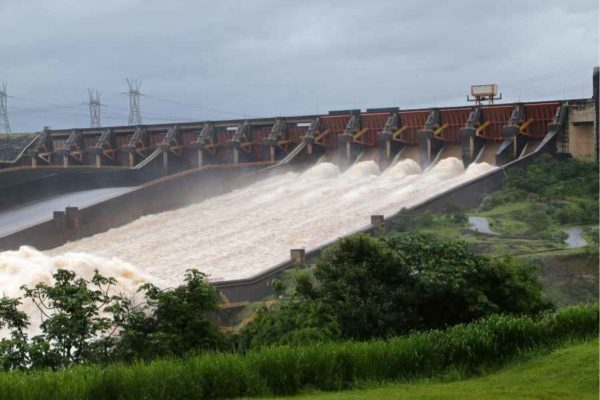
[382,157,598,306]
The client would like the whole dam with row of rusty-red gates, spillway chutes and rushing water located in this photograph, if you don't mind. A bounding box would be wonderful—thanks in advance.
[0,72,598,301]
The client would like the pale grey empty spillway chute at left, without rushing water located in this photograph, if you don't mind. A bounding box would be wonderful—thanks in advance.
[0,187,135,237]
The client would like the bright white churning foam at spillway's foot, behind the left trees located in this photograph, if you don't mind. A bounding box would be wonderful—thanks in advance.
[0,246,159,334]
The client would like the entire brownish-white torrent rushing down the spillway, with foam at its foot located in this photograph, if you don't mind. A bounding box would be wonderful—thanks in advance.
[0,158,494,295]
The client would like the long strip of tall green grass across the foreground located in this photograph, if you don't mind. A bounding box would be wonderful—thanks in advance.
[0,305,598,400]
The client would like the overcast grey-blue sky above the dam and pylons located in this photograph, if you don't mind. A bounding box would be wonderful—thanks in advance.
[0,0,599,132]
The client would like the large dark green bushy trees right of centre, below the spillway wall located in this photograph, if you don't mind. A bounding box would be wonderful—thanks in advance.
[242,235,550,347]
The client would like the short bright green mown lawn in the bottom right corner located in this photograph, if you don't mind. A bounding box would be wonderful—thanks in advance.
[255,339,598,400]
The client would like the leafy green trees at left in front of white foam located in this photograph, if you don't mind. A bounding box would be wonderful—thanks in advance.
[0,269,224,370]
